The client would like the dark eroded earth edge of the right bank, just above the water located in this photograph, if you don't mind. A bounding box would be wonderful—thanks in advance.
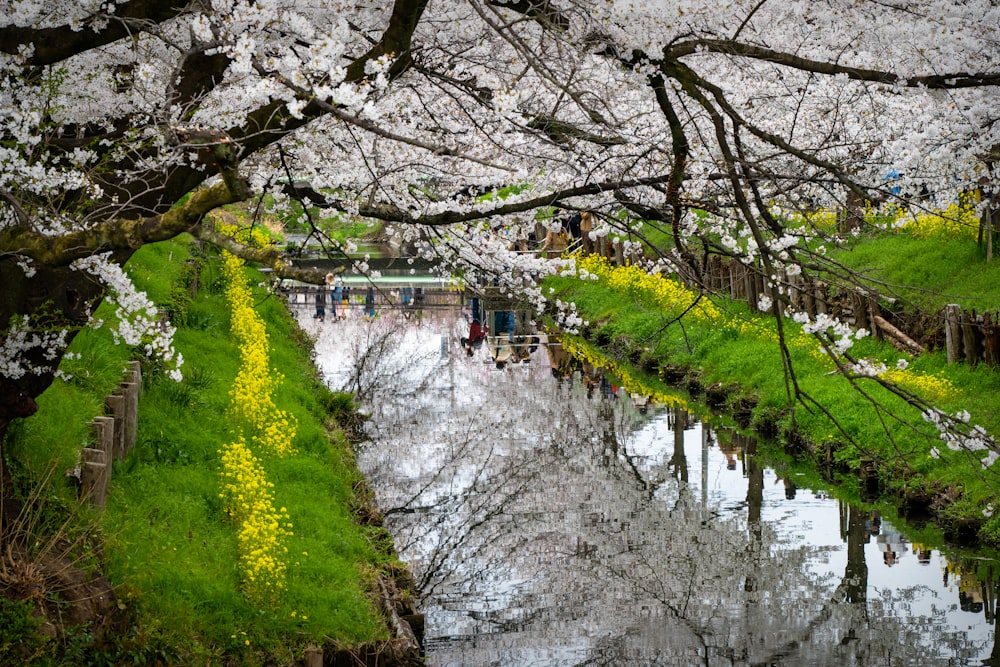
[550,281,1000,548]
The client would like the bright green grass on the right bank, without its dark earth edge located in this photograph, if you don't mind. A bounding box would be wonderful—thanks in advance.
[548,245,1000,543]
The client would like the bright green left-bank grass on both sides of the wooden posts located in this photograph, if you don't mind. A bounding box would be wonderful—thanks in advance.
[12,241,391,664]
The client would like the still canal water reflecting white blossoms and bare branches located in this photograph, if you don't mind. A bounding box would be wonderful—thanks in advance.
[297,298,1000,666]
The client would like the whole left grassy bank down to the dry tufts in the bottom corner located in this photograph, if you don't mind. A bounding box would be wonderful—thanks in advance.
[0,239,414,665]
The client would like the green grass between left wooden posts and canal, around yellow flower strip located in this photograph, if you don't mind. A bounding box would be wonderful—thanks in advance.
[108,240,392,664]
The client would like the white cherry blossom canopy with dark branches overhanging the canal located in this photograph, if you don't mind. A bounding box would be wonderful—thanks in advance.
[0,0,1000,470]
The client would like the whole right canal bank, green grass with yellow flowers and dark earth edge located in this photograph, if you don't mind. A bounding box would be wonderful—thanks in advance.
[546,248,1000,546]
